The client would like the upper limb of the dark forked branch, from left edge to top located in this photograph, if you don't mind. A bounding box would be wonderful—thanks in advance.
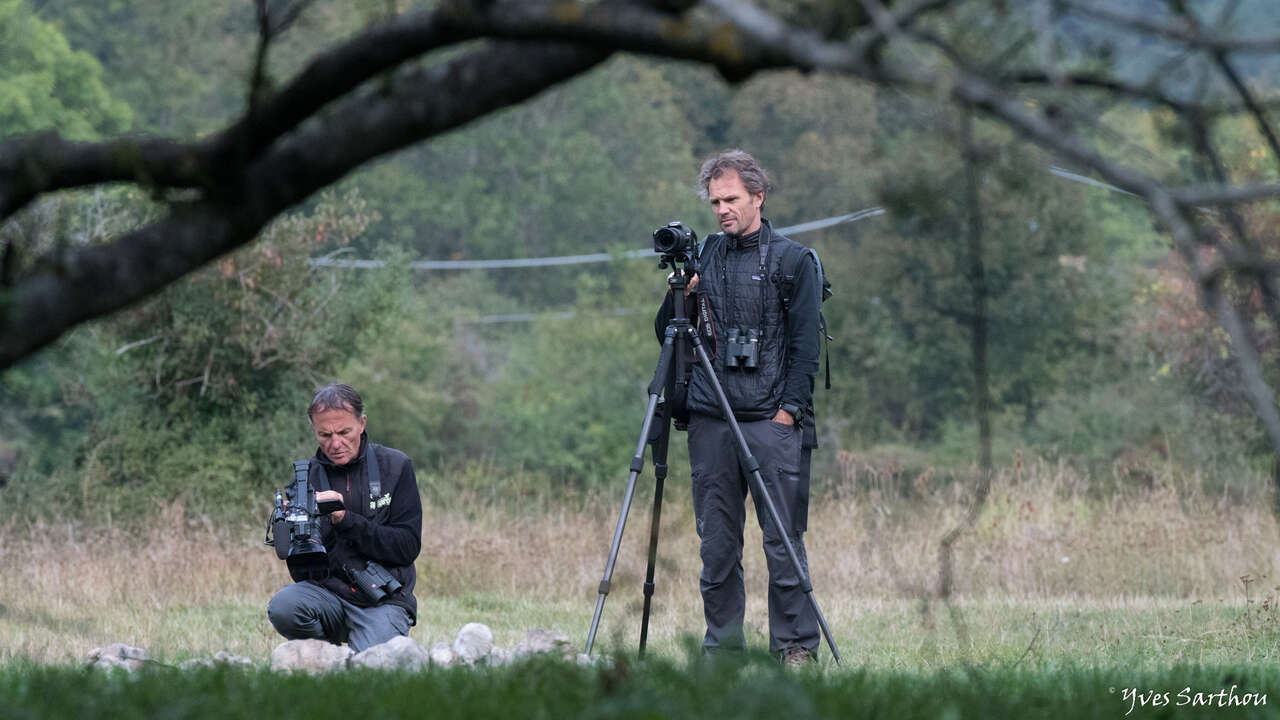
[0,0,721,220]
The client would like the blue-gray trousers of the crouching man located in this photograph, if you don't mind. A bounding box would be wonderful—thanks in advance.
[266,583,410,652]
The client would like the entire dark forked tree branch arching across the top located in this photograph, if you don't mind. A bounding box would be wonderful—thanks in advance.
[0,0,1280,386]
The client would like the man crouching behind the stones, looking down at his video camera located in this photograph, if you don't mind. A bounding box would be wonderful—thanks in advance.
[266,383,422,652]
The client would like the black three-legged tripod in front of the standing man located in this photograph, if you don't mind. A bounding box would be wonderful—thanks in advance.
[584,255,840,665]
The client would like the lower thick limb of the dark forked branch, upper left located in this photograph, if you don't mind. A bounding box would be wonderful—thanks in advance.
[0,37,608,369]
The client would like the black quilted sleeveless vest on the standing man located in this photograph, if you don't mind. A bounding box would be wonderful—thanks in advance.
[689,219,797,421]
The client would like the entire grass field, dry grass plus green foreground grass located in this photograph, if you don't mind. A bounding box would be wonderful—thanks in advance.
[0,457,1280,717]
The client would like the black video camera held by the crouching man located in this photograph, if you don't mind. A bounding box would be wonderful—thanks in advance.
[265,460,332,583]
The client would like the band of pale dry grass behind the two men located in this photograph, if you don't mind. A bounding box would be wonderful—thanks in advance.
[0,455,1280,667]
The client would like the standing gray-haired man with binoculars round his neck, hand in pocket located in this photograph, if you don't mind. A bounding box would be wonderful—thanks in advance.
[655,150,819,665]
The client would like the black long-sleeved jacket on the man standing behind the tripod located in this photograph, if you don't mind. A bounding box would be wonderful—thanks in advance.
[654,219,820,429]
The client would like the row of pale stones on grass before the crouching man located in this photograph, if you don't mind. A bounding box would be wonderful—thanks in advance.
[87,623,585,674]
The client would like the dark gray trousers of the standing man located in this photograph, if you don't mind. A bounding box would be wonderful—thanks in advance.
[689,414,819,653]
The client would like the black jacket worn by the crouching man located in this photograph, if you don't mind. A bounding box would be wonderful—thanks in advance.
[310,434,422,623]
